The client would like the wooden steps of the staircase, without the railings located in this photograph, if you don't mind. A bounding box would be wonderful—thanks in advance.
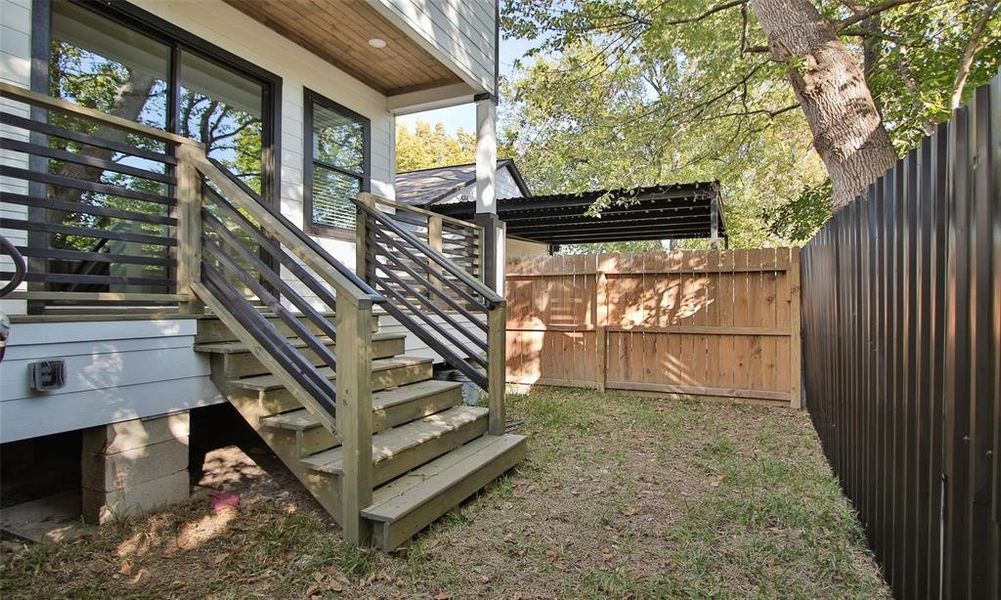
[195,316,527,551]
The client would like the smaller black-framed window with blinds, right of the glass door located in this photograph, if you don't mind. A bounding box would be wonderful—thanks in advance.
[303,90,370,238]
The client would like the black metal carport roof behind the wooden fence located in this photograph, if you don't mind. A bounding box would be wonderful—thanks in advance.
[431,181,727,244]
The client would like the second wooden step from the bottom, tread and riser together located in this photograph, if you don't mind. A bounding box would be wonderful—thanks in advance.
[302,406,489,485]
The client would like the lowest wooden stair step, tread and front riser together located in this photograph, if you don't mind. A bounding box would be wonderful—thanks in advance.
[361,434,528,552]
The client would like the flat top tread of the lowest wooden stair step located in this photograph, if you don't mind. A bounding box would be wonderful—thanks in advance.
[361,434,527,523]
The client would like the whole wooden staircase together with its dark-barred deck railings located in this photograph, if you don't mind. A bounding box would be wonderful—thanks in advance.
[0,82,526,550]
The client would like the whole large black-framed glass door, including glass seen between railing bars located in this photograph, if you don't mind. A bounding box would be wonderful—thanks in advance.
[37,0,281,308]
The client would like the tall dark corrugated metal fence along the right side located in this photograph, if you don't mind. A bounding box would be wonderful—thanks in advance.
[802,71,1001,598]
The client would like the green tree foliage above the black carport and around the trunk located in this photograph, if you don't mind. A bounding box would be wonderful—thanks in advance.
[502,0,1001,247]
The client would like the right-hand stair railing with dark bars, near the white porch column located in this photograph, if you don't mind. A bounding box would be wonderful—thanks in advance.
[356,193,507,435]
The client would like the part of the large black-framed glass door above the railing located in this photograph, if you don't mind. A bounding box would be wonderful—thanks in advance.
[45,2,281,202]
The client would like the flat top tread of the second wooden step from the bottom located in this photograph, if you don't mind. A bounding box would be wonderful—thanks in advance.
[302,406,489,475]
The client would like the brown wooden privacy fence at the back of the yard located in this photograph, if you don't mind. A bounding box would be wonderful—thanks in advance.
[506,248,800,406]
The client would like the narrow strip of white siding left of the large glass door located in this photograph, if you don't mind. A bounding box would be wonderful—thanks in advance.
[0,0,31,315]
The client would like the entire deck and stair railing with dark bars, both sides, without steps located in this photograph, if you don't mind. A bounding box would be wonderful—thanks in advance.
[0,84,505,544]
